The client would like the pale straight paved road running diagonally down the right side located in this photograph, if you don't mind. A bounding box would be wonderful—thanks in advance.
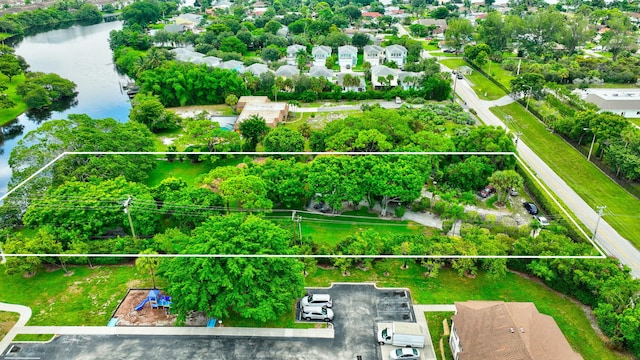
[448,69,640,278]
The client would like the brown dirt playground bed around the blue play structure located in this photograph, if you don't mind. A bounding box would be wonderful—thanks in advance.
[114,290,177,326]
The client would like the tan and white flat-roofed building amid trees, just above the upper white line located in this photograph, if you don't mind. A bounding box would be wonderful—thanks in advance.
[235,96,289,130]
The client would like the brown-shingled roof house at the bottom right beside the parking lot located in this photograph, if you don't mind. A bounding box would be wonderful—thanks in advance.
[449,301,582,360]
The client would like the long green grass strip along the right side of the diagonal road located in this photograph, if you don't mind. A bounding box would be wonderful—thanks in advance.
[491,103,640,248]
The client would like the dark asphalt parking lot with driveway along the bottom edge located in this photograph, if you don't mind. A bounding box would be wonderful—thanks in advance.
[1,284,415,360]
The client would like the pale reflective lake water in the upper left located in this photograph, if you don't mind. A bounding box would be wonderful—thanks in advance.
[0,21,131,195]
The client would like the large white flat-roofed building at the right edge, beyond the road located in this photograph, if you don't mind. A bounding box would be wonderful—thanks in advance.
[576,89,640,118]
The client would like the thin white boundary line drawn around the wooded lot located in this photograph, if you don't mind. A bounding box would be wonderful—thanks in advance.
[0,151,607,259]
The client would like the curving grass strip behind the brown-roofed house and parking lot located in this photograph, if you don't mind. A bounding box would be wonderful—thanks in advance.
[307,260,630,360]
